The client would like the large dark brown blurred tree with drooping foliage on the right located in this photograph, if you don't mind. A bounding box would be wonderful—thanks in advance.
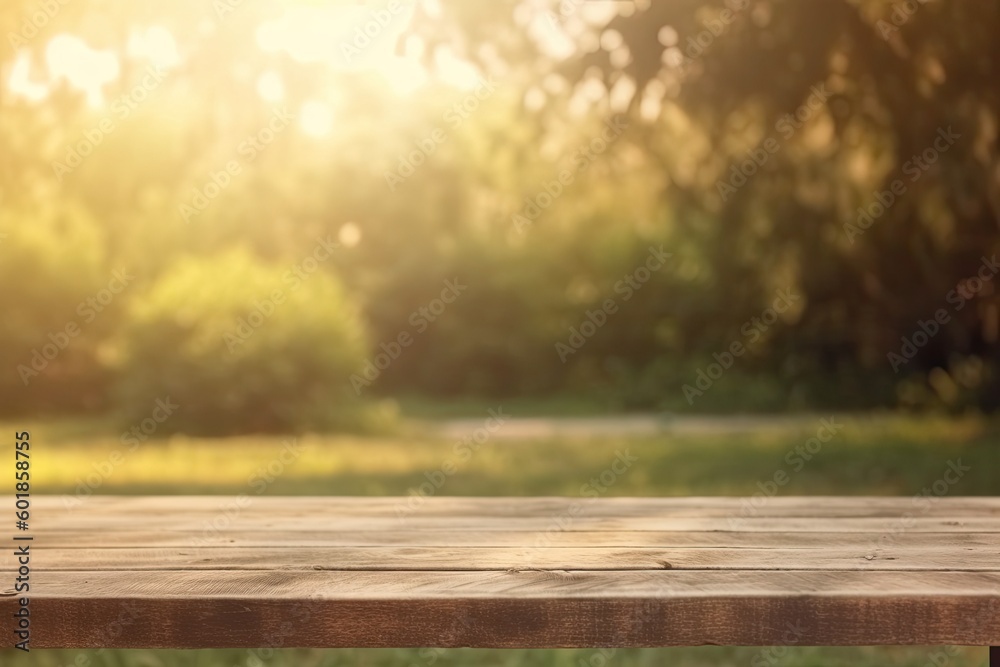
[417,0,1000,408]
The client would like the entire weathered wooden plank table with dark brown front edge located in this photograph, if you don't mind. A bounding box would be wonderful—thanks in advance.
[0,496,1000,648]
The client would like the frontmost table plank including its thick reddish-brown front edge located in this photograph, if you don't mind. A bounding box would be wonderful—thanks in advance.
[0,570,1000,648]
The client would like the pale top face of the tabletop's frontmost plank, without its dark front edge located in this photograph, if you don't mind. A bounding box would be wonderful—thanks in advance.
[9,569,1000,604]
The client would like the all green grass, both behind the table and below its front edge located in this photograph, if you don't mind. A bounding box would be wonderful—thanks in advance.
[0,412,1000,667]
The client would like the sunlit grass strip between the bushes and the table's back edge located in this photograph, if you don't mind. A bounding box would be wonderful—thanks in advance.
[15,408,1000,496]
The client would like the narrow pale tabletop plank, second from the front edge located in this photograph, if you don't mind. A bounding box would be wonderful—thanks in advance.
[0,539,1000,572]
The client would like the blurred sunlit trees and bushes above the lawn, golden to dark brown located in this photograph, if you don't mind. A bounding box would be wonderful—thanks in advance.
[0,0,1000,432]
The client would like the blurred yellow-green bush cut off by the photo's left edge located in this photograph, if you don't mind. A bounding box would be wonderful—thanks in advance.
[0,201,111,415]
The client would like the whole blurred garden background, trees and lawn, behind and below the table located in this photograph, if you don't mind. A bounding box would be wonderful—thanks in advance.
[0,0,1000,667]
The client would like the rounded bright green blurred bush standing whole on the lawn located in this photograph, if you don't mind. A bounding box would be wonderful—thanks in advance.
[119,250,365,435]
